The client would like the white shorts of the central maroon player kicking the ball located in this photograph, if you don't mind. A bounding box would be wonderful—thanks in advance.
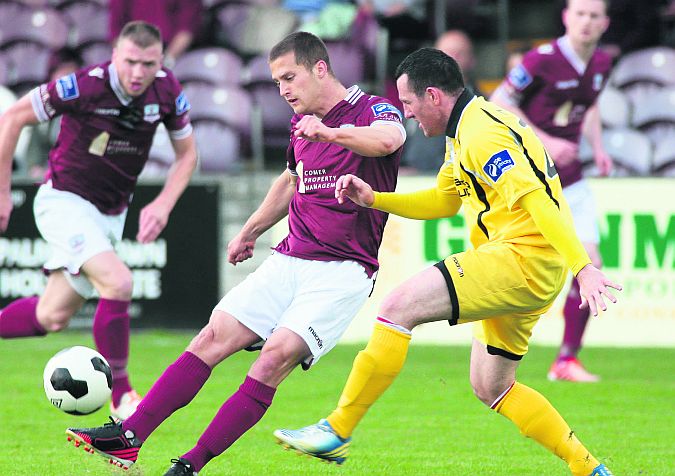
[215,252,374,368]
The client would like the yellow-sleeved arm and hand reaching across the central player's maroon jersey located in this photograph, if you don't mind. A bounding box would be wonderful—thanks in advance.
[335,172,462,220]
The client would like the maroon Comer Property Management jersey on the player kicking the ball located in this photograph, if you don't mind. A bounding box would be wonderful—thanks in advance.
[276,86,405,276]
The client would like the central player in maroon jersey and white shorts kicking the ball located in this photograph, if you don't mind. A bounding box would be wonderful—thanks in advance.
[62,32,405,475]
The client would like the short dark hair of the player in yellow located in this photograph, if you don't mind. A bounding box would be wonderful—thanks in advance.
[395,48,464,97]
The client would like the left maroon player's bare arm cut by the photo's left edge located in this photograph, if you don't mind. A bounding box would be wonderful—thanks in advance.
[0,95,39,233]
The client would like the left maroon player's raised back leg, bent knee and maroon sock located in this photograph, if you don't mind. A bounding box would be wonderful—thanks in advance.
[0,270,84,339]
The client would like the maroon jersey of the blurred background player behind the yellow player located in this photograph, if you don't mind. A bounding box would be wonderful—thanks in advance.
[506,36,612,186]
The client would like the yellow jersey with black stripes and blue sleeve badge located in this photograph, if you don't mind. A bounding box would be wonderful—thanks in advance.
[444,90,564,248]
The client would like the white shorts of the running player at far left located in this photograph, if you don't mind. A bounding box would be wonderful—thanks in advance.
[33,182,127,299]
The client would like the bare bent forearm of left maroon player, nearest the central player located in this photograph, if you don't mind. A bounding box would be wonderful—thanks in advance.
[136,134,197,243]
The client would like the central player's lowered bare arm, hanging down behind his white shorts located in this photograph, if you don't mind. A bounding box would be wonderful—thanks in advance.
[227,170,297,265]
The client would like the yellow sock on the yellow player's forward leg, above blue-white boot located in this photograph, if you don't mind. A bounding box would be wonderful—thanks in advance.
[327,318,411,438]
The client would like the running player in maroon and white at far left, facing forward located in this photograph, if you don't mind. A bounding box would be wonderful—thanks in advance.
[0,22,197,419]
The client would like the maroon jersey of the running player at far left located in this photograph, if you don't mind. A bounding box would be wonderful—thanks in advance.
[30,62,192,215]
